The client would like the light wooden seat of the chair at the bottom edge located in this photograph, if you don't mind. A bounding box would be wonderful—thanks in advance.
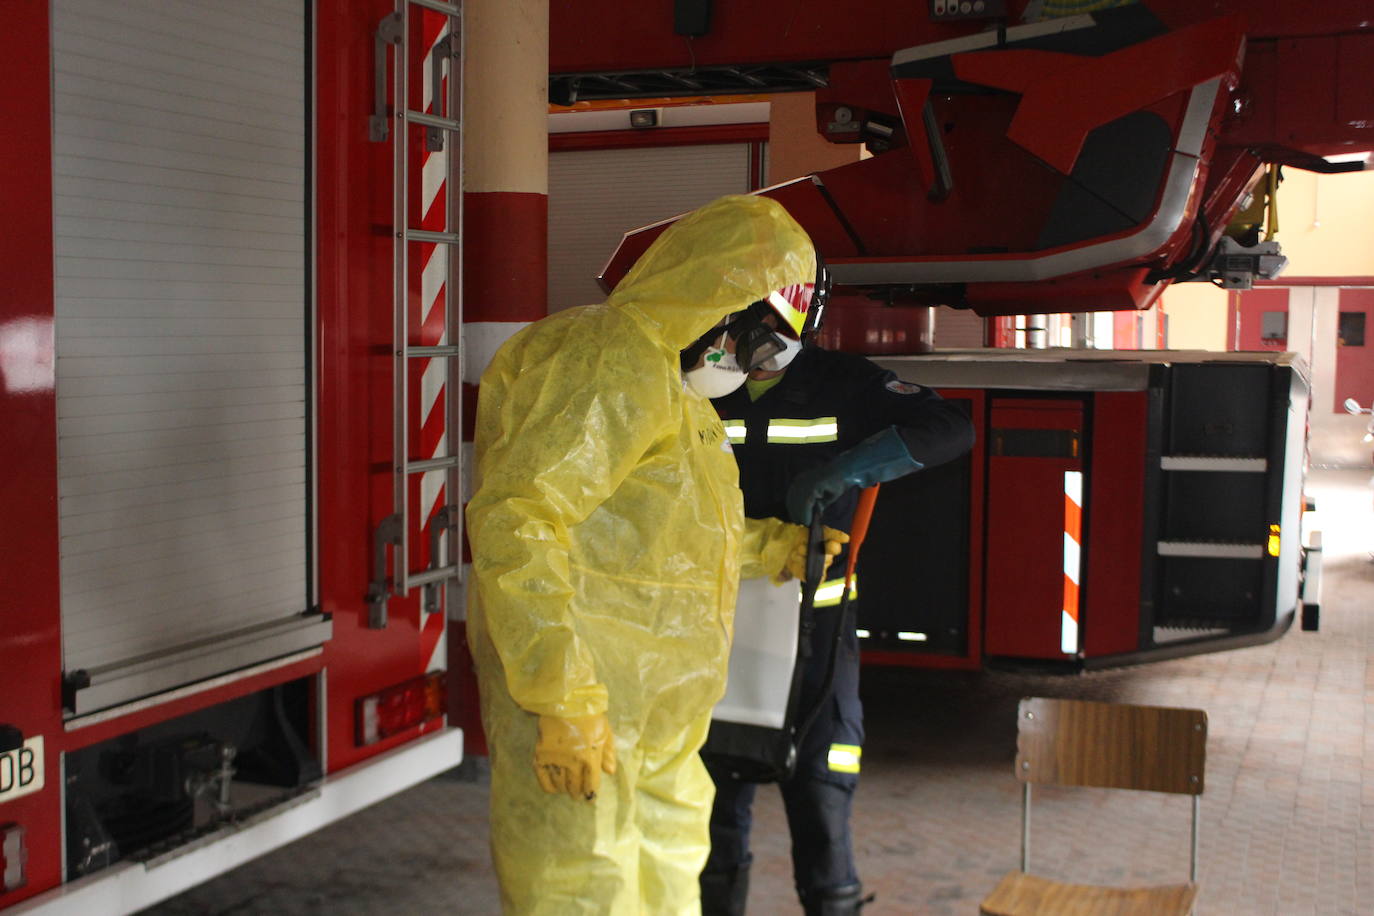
[978,872,1198,916]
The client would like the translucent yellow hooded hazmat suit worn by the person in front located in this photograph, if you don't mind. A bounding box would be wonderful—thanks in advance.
[467,196,816,916]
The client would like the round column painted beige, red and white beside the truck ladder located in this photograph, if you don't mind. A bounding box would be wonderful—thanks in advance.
[449,0,548,754]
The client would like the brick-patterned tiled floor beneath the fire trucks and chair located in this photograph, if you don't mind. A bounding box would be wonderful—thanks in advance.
[150,471,1374,916]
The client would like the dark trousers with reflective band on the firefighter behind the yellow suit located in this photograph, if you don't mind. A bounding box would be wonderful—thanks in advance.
[703,602,863,912]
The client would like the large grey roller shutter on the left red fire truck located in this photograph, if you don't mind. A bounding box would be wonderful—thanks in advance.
[54,0,309,670]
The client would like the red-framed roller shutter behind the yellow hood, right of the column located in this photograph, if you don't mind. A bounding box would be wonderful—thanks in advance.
[548,143,749,312]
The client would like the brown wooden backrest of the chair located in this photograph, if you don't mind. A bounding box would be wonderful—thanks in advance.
[1017,696,1206,795]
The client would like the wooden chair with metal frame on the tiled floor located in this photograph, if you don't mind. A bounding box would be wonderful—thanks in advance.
[980,698,1206,916]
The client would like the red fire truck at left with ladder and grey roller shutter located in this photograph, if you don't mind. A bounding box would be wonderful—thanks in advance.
[0,0,463,913]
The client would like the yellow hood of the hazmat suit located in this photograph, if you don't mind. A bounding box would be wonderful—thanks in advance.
[606,195,816,350]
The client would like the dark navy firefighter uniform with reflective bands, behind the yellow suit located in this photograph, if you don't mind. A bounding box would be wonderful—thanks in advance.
[701,289,973,916]
